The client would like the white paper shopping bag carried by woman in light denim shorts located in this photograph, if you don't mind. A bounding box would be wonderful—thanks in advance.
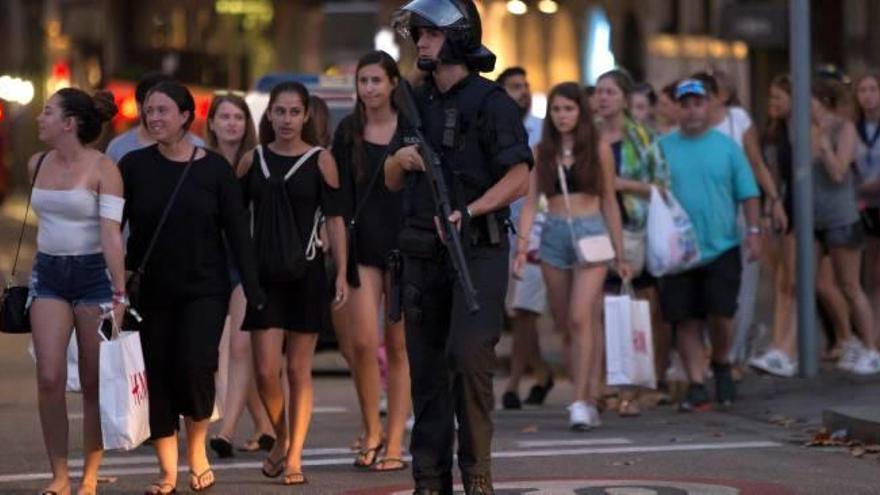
[605,294,657,388]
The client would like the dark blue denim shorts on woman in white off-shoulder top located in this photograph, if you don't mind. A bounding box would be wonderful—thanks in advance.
[30,253,113,306]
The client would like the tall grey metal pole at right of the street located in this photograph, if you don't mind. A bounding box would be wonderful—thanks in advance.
[789,0,819,378]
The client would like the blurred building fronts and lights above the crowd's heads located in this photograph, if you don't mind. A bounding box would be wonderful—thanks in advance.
[0,0,880,192]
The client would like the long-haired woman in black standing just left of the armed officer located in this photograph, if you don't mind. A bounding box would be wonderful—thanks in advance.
[333,51,410,471]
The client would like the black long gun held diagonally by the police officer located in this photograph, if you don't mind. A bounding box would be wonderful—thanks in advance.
[397,79,480,314]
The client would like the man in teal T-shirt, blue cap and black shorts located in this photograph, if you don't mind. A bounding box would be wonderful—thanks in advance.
[660,79,761,412]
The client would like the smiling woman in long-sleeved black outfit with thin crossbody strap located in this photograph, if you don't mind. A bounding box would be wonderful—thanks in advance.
[119,82,265,494]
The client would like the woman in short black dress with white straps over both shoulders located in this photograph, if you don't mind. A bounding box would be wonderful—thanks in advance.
[239,82,348,485]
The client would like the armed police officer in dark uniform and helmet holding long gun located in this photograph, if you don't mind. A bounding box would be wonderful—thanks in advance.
[385,0,533,495]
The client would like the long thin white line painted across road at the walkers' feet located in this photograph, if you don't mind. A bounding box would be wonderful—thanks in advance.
[0,441,782,483]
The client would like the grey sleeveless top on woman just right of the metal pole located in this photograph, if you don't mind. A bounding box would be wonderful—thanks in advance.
[813,120,859,230]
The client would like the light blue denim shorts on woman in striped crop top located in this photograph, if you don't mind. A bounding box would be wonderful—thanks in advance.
[540,214,608,270]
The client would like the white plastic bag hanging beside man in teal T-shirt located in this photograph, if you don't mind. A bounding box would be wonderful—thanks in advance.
[646,187,700,277]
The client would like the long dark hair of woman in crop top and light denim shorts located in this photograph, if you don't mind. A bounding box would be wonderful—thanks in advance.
[537,82,603,196]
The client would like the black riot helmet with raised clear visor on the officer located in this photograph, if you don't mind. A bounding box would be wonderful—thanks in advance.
[392,0,495,72]
